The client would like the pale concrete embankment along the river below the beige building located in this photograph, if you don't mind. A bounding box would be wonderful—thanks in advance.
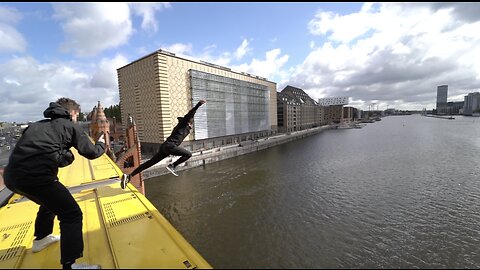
[142,126,332,180]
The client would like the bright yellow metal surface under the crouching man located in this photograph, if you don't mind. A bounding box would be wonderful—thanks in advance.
[0,151,212,269]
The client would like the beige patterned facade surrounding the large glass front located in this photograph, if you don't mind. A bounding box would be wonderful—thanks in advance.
[117,50,277,147]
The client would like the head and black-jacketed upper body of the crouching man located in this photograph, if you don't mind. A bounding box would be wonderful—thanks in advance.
[4,102,105,187]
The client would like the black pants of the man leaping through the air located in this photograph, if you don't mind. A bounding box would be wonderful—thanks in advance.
[130,143,192,176]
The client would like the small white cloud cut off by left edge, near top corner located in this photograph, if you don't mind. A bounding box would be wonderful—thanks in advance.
[0,6,27,53]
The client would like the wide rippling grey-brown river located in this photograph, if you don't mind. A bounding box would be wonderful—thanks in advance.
[145,115,480,269]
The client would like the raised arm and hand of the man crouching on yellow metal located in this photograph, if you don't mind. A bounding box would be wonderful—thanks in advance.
[72,125,105,159]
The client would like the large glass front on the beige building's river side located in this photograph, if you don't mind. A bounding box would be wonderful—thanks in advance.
[189,69,270,140]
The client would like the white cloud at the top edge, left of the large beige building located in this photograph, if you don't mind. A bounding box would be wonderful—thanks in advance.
[53,3,133,56]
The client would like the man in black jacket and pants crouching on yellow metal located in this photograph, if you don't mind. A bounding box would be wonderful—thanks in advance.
[4,98,105,269]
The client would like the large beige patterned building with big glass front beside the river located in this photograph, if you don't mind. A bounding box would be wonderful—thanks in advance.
[117,50,277,152]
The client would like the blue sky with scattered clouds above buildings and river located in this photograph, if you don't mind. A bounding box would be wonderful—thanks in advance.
[0,2,480,123]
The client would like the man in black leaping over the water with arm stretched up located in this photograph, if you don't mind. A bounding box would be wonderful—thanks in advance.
[120,99,207,189]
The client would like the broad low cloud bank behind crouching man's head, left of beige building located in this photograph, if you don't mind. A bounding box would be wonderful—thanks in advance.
[0,56,127,122]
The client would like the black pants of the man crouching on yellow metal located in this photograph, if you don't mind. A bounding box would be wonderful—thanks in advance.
[5,181,83,264]
